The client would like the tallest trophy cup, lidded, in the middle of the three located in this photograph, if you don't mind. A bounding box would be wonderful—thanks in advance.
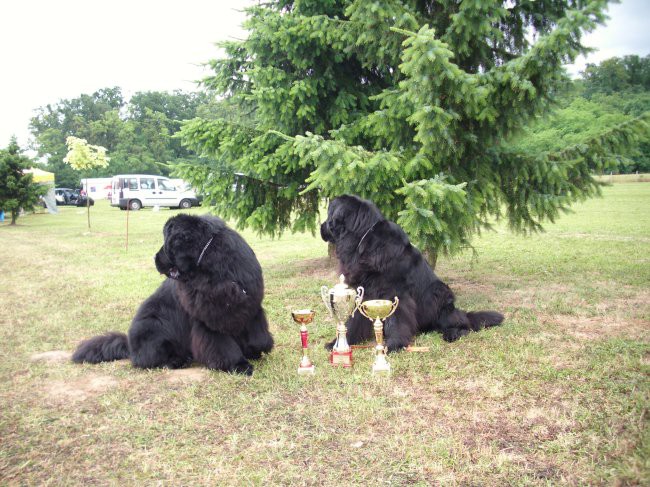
[321,274,363,367]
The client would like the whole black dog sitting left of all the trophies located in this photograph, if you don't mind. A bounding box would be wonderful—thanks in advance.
[72,214,273,375]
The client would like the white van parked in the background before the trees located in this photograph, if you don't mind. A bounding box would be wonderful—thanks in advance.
[111,174,201,211]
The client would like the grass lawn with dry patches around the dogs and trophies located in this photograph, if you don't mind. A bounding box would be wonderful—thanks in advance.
[0,183,650,486]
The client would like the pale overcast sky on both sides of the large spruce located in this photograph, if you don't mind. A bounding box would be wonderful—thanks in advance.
[0,0,650,152]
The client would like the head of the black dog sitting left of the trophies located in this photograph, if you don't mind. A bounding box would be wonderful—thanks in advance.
[154,214,213,280]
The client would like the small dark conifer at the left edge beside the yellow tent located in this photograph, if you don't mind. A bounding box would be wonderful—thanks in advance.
[0,137,47,225]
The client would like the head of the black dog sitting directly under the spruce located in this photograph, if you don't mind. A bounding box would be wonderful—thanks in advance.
[320,194,384,244]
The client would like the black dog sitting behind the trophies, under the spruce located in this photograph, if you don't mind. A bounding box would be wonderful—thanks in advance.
[320,195,503,351]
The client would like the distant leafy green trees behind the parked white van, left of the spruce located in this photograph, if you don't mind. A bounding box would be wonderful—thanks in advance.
[31,88,207,187]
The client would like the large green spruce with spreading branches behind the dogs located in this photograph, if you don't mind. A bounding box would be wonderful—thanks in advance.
[177,0,648,265]
